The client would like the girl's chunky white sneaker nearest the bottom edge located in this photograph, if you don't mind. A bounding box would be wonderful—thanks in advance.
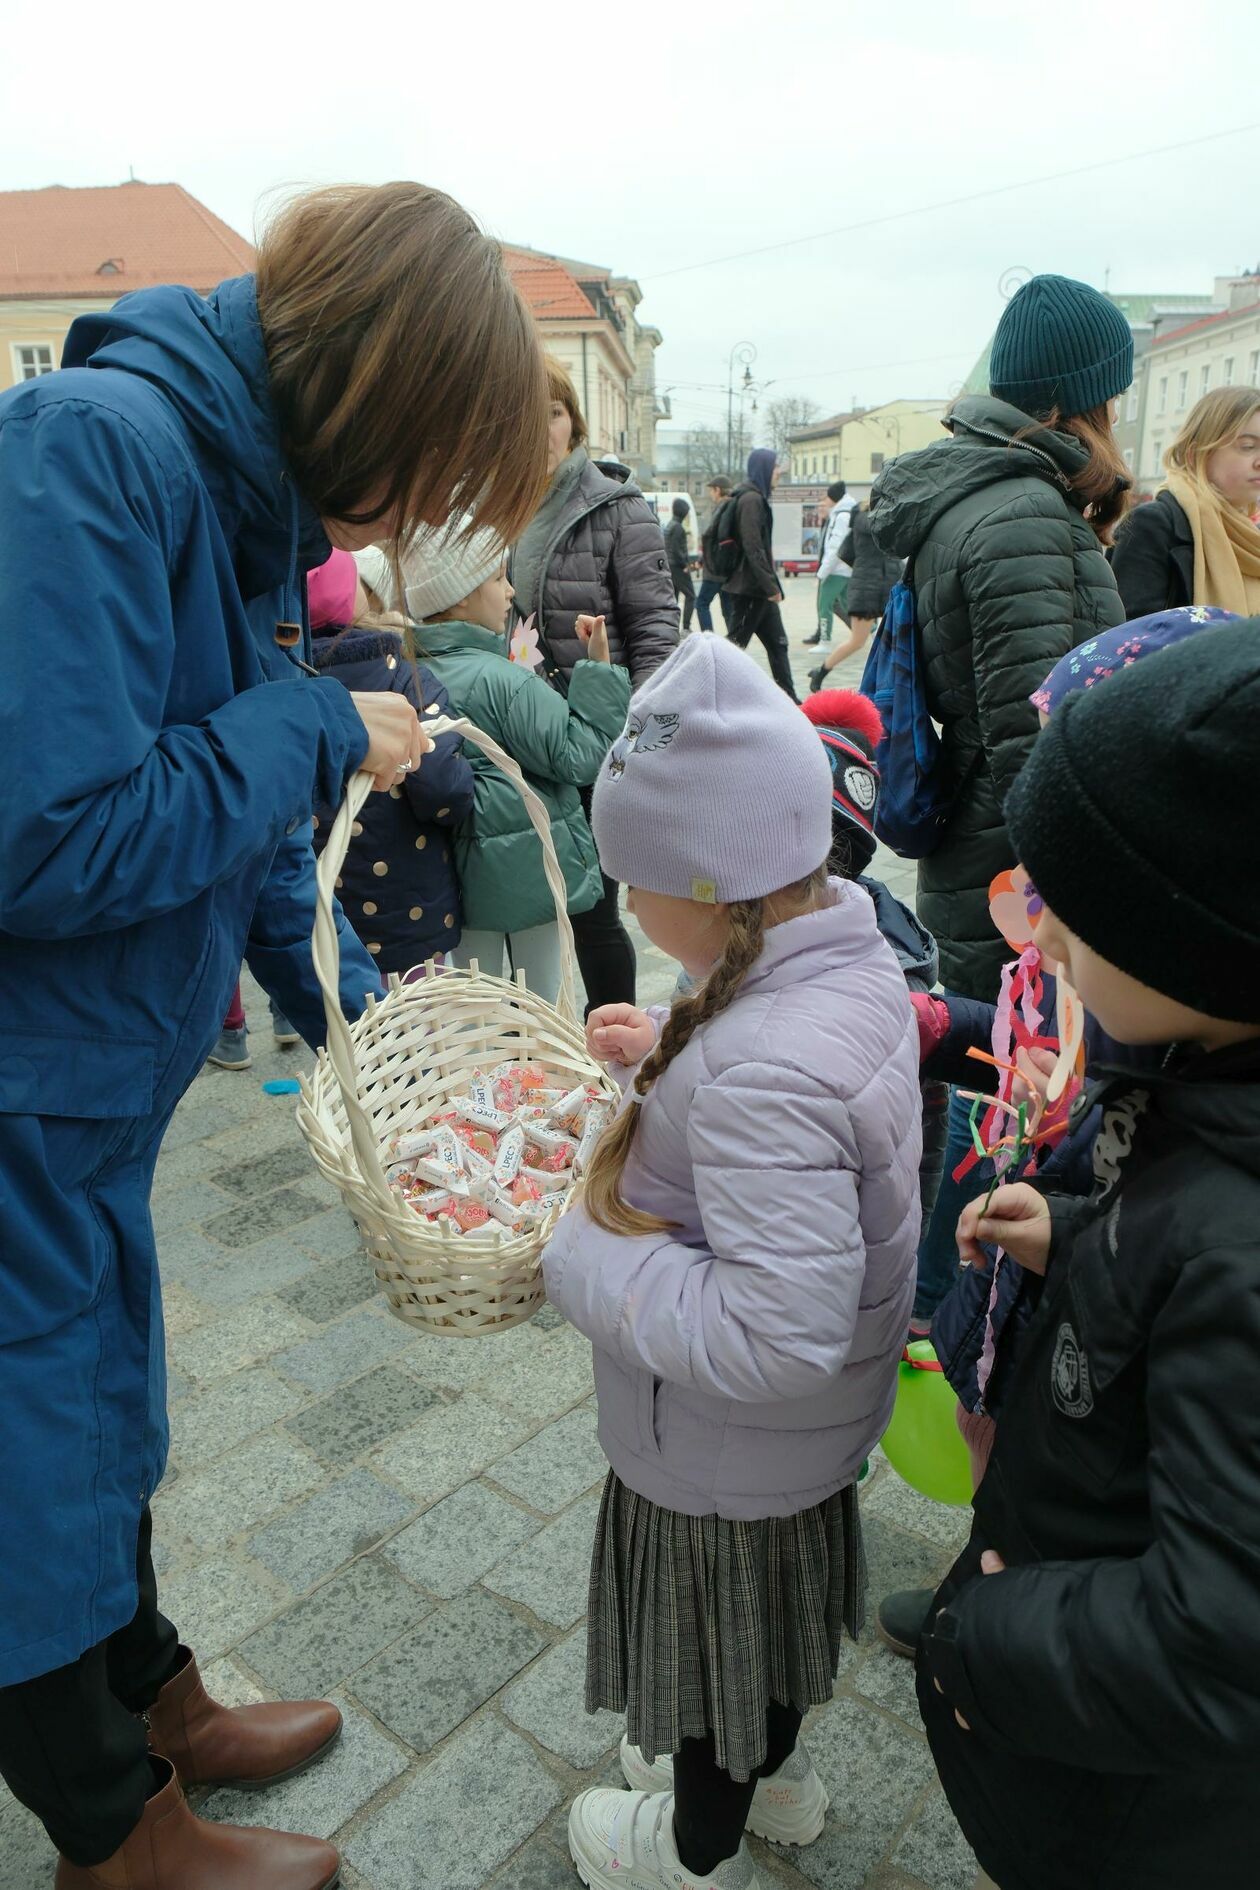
[569,1790,765,1890]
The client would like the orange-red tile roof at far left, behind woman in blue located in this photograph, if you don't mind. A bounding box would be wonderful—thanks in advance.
[0,183,253,299]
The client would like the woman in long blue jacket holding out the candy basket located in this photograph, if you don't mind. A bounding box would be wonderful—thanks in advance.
[0,183,546,1890]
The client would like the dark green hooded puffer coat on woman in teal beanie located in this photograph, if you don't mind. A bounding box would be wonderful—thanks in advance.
[872,395,1124,998]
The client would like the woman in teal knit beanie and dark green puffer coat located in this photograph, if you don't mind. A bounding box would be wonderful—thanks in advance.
[871,276,1133,1345]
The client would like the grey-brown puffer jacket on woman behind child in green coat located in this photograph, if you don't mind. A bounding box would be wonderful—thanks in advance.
[513,461,678,688]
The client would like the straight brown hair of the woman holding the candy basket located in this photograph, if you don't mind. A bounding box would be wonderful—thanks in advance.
[257,183,548,541]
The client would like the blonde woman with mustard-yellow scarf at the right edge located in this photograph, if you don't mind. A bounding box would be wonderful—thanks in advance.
[1113,387,1260,618]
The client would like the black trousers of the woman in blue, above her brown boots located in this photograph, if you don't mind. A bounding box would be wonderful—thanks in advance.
[0,1508,179,1867]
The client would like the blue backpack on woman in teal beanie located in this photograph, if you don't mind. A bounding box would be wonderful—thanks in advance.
[861,569,954,860]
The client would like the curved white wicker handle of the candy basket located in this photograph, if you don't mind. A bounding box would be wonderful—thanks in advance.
[312,716,578,1206]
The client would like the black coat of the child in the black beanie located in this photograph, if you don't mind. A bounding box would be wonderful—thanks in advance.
[918,1043,1260,1890]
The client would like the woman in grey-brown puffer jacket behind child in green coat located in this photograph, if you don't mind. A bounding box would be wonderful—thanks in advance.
[508,357,678,1005]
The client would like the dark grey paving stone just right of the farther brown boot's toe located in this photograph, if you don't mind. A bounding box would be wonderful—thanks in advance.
[351,1589,546,1752]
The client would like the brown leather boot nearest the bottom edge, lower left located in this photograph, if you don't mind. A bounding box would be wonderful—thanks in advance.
[57,1760,342,1890]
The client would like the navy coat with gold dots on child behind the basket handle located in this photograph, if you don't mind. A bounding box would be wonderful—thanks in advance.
[315,629,472,973]
